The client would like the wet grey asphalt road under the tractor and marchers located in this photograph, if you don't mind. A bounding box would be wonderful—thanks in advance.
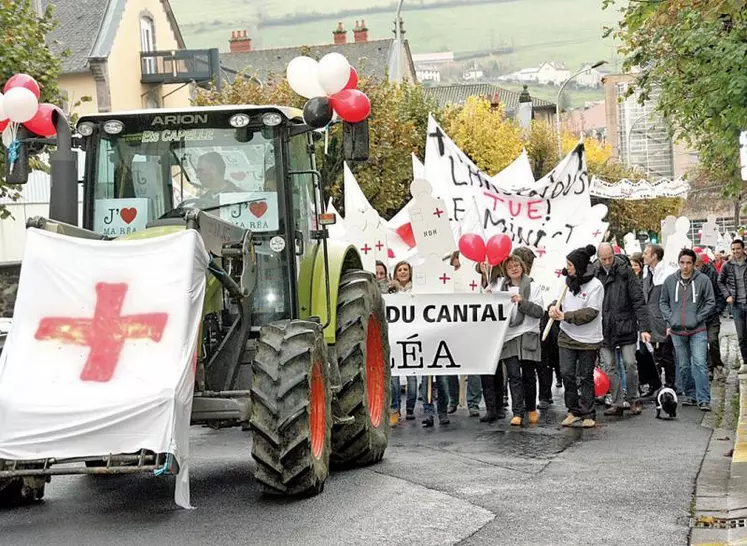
[0,378,711,546]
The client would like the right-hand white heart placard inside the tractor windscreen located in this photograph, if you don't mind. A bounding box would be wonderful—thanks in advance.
[224,191,279,233]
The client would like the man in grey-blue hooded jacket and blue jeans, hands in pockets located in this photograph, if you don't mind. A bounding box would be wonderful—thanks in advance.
[659,248,716,411]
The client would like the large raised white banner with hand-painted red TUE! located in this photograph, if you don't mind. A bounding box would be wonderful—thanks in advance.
[425,117,591,249]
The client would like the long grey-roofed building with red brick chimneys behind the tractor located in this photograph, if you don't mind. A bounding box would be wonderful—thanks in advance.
[220,21,418,82]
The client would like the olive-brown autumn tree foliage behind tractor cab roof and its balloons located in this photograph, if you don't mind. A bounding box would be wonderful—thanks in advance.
[194,69,436,217]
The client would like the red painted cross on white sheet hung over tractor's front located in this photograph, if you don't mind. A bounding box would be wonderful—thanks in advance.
[34,283,169,383]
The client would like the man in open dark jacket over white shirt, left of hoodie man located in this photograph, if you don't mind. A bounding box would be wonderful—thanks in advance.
[643,244,677,389]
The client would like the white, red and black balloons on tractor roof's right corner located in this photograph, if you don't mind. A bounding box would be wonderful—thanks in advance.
[286,53,371,129]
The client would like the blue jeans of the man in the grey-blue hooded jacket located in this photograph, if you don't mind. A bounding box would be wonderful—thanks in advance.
[672,330,711,404]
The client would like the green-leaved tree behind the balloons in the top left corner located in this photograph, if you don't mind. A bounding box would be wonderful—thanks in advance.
[0,0,62,219]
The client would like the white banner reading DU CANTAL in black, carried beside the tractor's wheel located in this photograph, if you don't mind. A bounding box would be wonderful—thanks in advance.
[384,292,514,376]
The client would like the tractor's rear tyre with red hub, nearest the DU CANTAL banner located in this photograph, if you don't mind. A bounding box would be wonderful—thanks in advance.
[332,270,392,467]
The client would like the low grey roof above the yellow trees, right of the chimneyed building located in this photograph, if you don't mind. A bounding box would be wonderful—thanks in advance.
[425,83,555,122]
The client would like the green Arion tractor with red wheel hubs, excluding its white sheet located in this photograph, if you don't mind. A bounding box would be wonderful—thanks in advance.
[0,105,391,504]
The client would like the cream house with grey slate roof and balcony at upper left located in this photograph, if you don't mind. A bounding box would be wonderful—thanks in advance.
[37,0,194,114]
